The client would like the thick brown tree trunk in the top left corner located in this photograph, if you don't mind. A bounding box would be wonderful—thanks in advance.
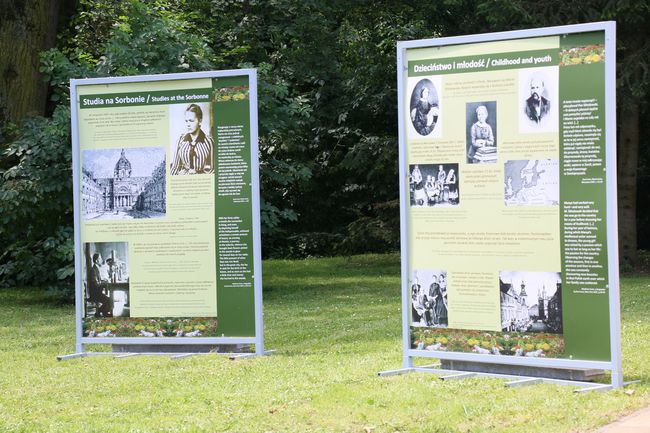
[0,0,60,125]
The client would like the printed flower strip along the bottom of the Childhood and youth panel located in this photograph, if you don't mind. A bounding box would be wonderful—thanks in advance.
[411,327,564,357]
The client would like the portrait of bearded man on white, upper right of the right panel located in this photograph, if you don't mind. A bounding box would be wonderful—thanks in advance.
[519,66,559,133]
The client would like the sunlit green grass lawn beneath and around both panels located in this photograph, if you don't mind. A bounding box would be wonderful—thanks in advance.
[0,255,650,433]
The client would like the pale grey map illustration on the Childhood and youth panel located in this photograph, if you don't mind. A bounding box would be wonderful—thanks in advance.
[503,159,560,206]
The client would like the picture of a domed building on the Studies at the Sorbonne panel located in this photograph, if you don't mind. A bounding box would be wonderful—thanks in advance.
[81,147,167,220]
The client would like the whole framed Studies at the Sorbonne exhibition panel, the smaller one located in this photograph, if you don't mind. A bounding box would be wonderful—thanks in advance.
[70,70,264,353]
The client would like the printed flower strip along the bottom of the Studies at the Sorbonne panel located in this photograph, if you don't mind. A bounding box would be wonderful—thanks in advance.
[83,317,217,337]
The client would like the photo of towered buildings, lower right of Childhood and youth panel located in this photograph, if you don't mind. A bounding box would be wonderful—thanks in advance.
[499,271,562,334]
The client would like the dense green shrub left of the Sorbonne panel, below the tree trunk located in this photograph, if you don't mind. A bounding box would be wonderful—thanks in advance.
[0,106,74,285]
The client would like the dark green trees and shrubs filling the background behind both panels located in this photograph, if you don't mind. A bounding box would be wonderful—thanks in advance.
[0,0,650,288]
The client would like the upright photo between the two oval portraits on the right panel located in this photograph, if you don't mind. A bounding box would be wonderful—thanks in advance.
[465,101,497,164]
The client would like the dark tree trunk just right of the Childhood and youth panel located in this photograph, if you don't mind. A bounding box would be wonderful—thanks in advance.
[617,103,639,266]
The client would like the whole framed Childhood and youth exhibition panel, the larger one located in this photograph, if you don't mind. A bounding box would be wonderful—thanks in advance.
[397,22,622,386]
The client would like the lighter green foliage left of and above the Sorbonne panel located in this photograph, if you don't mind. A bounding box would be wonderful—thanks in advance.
[0,1,223,287]
